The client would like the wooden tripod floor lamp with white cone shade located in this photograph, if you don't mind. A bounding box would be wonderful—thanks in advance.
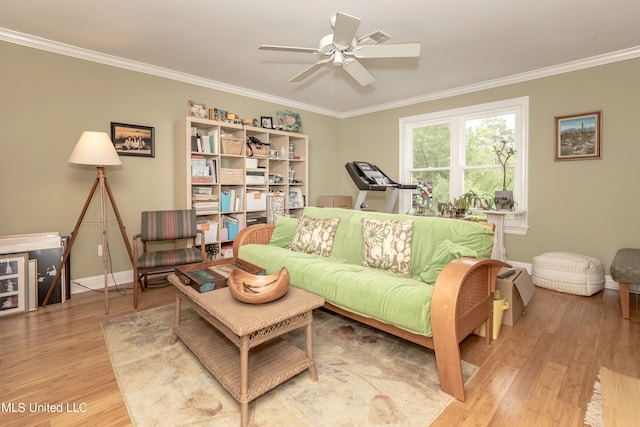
[42,131,133,313]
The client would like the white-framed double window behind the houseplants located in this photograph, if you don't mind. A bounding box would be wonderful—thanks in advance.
[399,97,529,234]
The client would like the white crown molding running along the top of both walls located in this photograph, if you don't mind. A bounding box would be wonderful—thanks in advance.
[0,28,640,119]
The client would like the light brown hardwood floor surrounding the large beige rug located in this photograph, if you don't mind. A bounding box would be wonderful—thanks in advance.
[0,278,640,427]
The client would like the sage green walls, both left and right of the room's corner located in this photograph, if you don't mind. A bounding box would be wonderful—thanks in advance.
[0,42,640,288]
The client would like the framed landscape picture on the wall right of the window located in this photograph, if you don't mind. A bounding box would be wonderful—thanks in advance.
[555,111,602,161]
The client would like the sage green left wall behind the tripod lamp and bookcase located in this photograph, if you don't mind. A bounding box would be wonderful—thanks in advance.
[0,42,341,279]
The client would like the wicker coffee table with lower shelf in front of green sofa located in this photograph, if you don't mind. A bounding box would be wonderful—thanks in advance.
[169,274,324,426]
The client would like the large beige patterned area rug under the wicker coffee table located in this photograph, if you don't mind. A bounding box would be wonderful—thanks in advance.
[102,304,477,427]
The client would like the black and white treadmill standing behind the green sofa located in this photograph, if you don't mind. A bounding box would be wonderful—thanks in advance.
[344,161,418,213]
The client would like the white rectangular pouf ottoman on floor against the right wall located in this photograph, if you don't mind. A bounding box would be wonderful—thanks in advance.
[531,252,604,296]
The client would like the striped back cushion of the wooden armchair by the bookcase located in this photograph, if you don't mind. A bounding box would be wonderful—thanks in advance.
[140,209,197,242]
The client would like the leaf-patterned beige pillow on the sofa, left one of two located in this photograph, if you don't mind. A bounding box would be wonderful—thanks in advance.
[289,214,340,256]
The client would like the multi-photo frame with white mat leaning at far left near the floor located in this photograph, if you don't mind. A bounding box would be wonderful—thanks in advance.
[0,253,29,316]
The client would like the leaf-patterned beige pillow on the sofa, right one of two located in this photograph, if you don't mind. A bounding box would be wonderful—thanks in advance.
[361,218,413,274]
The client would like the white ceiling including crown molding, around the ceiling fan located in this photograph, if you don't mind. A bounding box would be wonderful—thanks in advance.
[0,0,640,116]
